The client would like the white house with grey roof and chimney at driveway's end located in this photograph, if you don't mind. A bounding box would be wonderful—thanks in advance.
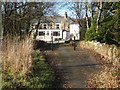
[31,12,79,42]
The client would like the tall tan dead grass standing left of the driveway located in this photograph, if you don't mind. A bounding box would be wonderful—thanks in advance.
[2,37,33,76]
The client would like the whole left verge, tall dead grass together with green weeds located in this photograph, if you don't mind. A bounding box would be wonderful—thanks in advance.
[2,37,54,89]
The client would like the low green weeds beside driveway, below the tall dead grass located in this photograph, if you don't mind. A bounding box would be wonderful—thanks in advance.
[2,51,54,89]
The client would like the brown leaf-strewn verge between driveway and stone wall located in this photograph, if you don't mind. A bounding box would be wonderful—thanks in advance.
[87,50,119,88]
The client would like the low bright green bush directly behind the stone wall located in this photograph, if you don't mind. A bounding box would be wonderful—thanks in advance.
[85,23,118,45]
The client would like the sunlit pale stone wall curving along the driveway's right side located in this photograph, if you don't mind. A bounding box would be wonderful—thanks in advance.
[79,41,120,66]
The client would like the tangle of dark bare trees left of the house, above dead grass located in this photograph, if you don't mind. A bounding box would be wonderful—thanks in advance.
[2,2,55,35]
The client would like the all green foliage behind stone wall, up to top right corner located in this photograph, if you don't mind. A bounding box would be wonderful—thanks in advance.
[85,2,120,45]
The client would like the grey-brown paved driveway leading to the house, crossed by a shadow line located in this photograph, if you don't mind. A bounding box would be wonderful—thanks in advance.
[44,46,101,88]
